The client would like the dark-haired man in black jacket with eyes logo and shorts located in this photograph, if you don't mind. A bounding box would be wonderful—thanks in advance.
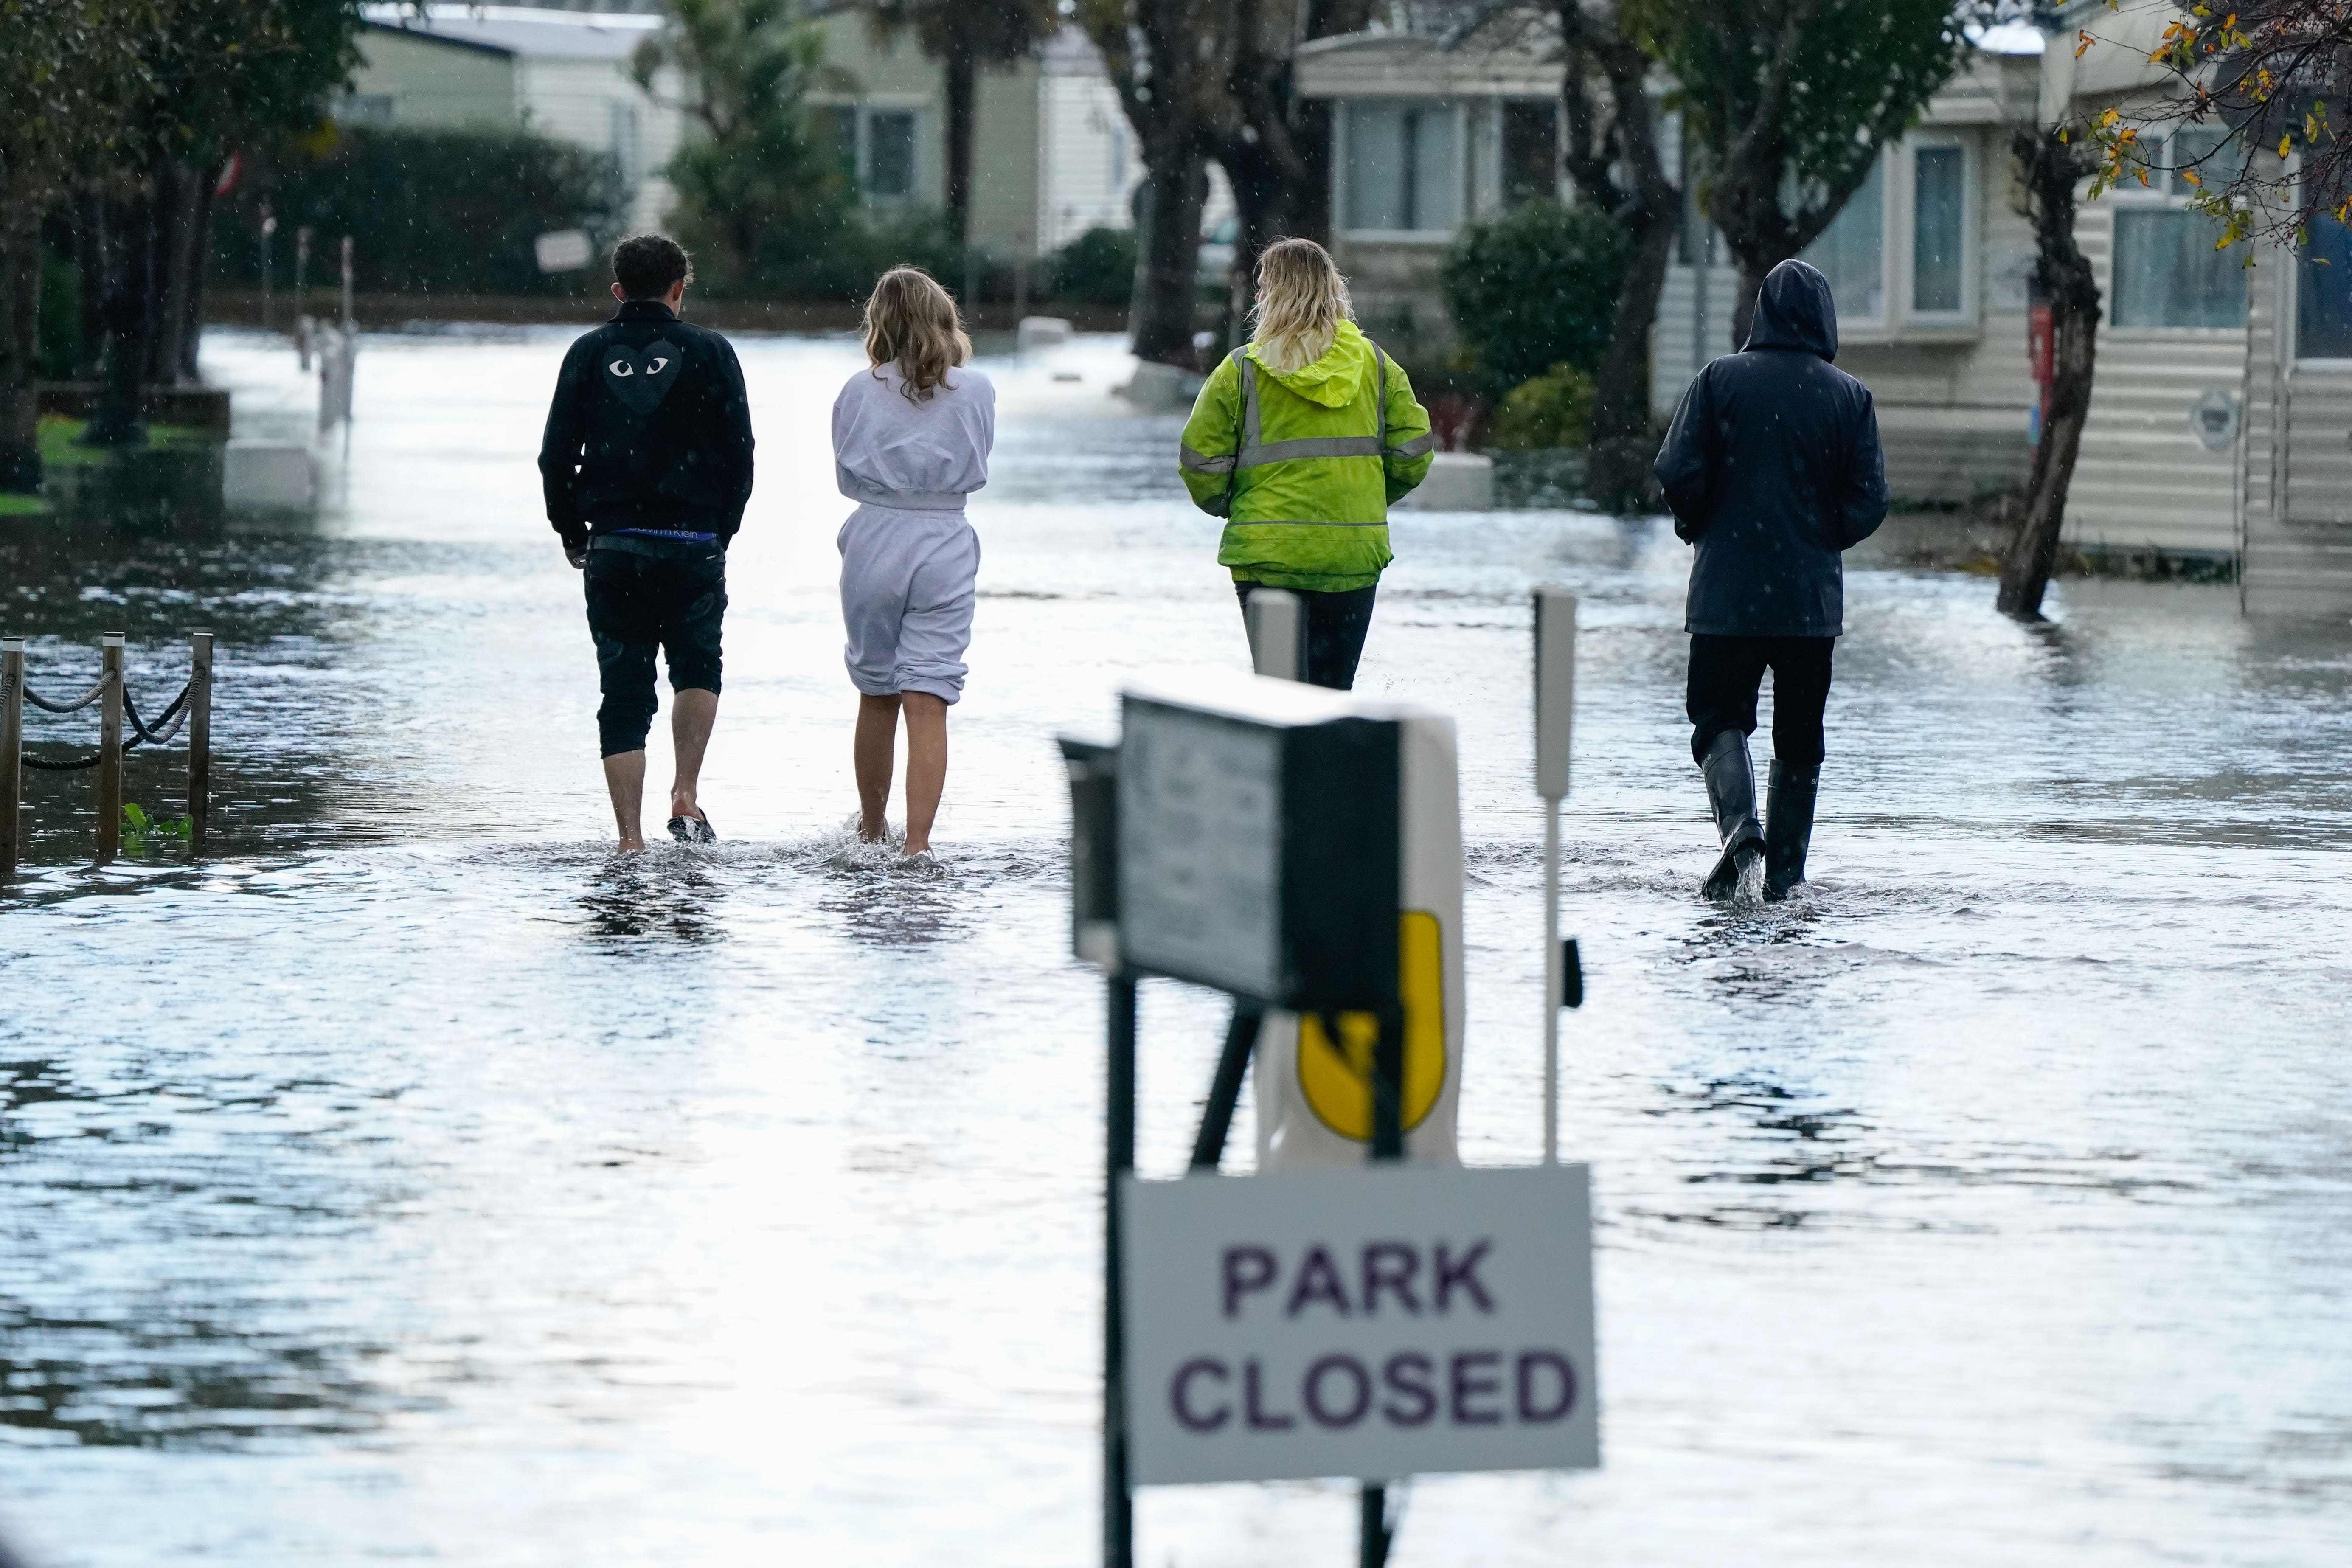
[539,235,750,849]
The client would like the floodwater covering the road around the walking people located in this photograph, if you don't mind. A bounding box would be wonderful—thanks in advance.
[0,334,2352,1568]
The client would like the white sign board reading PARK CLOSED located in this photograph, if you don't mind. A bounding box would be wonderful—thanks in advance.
[1120,1163,1599,1486]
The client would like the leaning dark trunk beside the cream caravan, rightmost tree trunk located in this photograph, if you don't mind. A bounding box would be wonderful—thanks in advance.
[1995,127,2100,621]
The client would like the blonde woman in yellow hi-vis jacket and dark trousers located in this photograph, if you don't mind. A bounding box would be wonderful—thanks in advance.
[1181,240,1432,691]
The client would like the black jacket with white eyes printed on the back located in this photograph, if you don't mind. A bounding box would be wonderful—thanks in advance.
[539,298,750,550]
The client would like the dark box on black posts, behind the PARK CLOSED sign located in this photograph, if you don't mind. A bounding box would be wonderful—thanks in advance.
[1061,691,1404,1568]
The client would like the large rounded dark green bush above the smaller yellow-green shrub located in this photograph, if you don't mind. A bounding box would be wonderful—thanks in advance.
[1444,202,1625,390]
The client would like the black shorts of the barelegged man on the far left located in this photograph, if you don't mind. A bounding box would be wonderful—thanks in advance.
[581,545,727,757]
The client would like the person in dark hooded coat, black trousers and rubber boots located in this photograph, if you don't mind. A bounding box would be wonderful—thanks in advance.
[1656,261,1886,898]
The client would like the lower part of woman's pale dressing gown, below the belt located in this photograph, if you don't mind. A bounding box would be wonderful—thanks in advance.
[840,506,981,703]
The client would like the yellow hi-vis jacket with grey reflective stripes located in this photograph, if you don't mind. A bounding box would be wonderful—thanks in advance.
[1181,322,1435,593]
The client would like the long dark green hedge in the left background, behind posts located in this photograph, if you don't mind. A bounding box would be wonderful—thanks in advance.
[212,127,623,294]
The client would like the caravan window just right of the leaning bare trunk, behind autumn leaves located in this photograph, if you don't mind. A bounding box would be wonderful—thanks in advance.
[2114,132,2246,327]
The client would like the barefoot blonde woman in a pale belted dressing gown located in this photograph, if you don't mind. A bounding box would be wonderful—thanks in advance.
[833,266,997,856]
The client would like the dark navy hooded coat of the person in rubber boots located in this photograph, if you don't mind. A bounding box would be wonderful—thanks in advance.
[1653,261,1886,637]
